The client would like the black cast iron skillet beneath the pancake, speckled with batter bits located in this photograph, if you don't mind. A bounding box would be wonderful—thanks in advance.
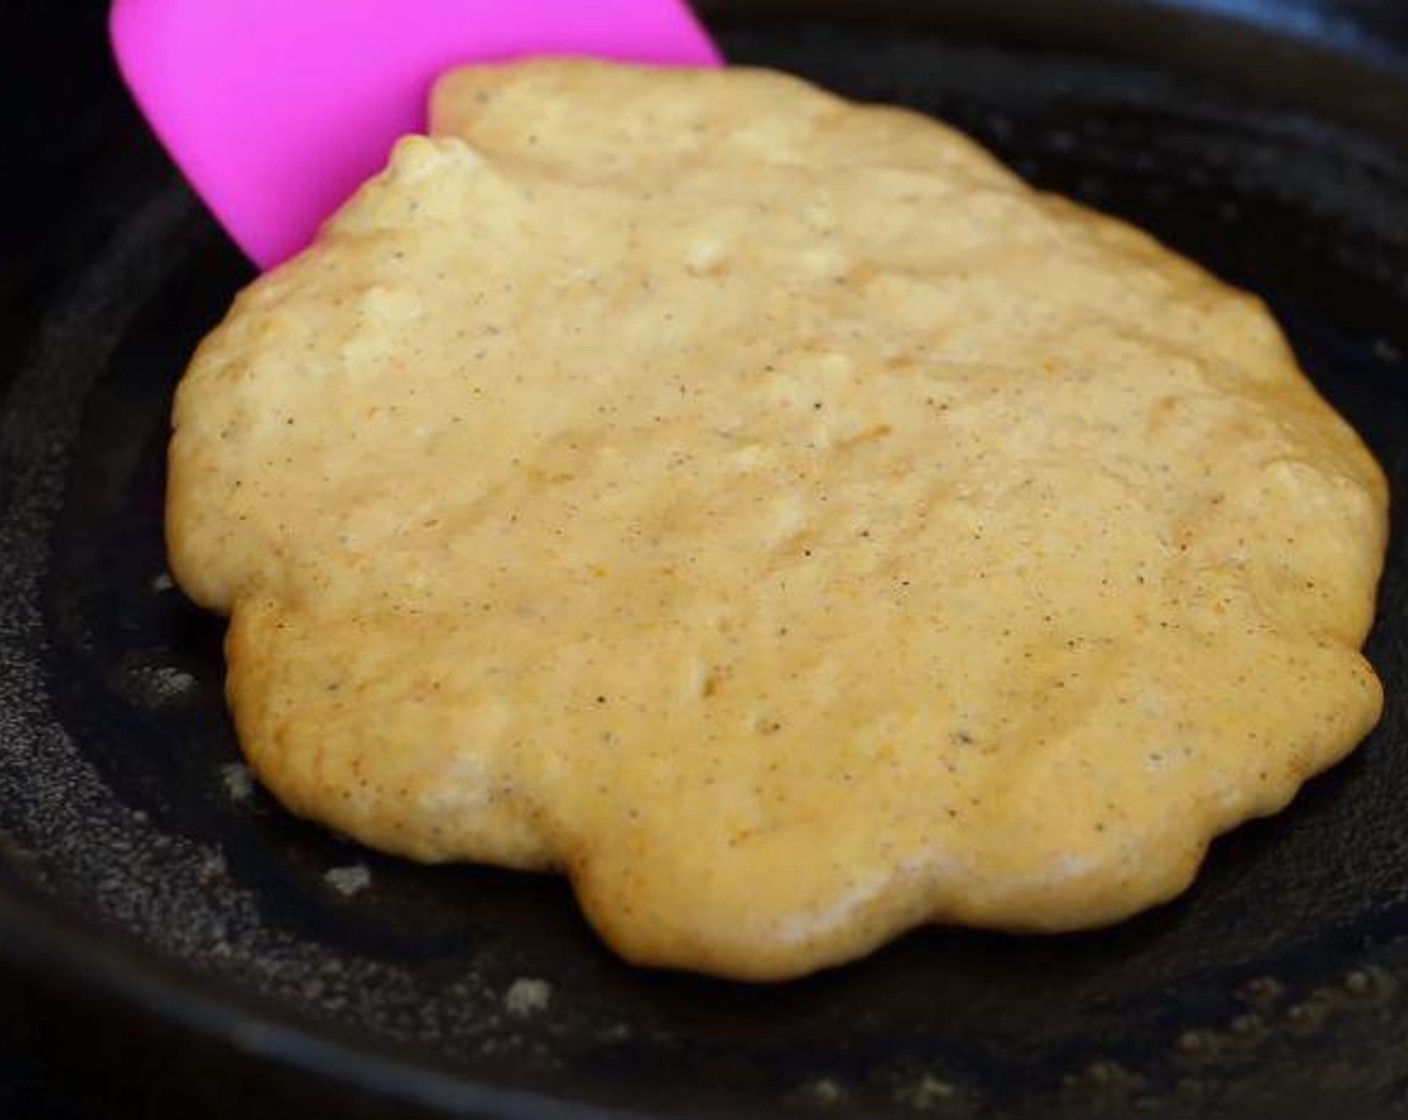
[0,0,1408,1120]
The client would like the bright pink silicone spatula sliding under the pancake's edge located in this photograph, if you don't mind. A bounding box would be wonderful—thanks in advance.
[111,0,719,268]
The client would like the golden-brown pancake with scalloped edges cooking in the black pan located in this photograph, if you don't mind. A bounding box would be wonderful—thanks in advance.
[168,62,1385,979]
